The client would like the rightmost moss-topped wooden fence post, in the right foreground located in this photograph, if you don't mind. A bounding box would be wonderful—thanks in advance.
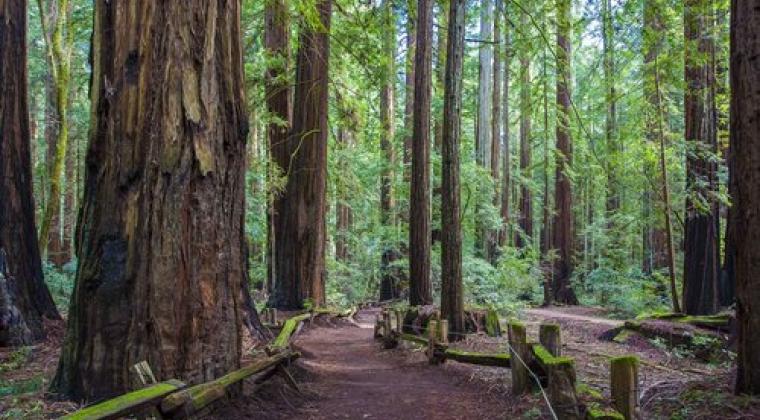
[610,356,639,420]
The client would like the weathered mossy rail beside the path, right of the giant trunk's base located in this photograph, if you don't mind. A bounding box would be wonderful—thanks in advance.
[160,351,301,418]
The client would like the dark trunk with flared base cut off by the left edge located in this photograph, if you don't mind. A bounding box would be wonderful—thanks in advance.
[0,0,60,347]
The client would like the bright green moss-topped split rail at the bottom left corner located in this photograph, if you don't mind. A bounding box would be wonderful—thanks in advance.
[62,380,186,420]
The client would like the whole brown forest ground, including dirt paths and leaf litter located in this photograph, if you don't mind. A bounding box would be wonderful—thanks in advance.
[0,307,760,420]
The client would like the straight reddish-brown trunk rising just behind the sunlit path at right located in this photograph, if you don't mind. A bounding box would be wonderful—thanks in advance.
[552,0,578,305]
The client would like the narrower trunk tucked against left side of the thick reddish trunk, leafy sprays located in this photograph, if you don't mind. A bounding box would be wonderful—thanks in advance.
[264,0,293,302]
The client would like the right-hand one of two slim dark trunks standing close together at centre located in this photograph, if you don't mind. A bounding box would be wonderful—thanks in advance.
[441,0,466,338]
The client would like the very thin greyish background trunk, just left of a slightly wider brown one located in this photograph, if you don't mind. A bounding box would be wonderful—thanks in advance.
[498,7,512,247]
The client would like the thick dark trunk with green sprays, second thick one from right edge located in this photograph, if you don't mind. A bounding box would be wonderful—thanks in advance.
[683,0,720,315]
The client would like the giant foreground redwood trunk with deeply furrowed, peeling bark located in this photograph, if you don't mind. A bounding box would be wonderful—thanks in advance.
[52,0,260,400]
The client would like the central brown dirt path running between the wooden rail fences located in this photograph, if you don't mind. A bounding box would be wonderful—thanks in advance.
[286,311,504,420]
